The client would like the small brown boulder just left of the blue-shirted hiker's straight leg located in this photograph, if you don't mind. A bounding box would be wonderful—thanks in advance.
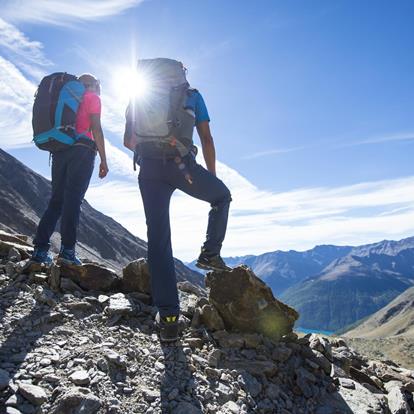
[121,258,151,295]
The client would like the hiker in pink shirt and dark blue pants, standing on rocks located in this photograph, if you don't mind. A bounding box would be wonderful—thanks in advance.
[32,74,108,265]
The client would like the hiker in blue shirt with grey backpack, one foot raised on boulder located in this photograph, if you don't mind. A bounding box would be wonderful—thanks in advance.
[124,58,231,341]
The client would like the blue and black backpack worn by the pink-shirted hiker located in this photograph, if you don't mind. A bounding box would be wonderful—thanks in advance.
[32,72,85,152]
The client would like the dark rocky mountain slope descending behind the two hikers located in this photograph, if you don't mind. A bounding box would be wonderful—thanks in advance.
[0,149,203,285]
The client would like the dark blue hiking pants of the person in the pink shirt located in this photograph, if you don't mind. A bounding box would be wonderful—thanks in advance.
[34,145,96,249]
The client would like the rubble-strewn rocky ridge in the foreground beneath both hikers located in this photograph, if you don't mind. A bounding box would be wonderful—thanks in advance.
[0,231,414,414]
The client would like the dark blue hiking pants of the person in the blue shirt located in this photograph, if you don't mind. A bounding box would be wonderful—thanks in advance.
[138,155,231,316]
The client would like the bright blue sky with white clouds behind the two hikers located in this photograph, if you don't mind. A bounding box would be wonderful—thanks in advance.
[0,0,414,260]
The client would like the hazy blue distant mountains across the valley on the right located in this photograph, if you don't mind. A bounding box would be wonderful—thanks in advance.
[190,237,414,331]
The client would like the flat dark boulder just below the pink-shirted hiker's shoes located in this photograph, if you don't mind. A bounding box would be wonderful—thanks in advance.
[60,263,120,292]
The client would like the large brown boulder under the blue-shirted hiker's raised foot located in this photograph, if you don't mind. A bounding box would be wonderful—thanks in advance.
[206,266,299,339]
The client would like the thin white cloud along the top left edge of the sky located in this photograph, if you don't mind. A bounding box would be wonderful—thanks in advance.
[1,0,143,26]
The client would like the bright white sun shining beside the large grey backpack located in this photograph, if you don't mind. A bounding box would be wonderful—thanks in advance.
[113,67,150,102]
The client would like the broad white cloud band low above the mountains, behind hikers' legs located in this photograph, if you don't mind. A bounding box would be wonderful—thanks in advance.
[87,157,414,260]
